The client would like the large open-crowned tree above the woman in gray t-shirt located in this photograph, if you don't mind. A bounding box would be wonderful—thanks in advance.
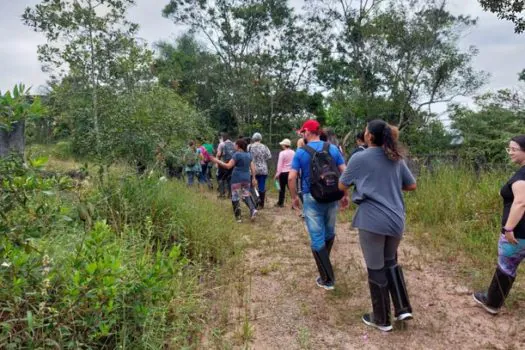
[309,0,485,129]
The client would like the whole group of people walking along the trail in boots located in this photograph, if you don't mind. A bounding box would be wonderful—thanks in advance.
[179,119,525,332]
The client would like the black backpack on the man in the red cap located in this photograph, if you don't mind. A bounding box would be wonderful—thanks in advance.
[304,142,344,203]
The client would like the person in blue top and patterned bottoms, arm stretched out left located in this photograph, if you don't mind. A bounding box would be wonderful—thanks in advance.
[211,139,257,222]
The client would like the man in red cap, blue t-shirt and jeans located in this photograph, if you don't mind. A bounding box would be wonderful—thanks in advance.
[288,120,348,290]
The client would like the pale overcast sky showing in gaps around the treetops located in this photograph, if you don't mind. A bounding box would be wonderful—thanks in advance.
[0,0,525,115]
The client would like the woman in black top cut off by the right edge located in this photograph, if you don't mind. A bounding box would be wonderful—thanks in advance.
[473,135,525,315]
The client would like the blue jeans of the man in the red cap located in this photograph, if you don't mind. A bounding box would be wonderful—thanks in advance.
[303,193,339,251]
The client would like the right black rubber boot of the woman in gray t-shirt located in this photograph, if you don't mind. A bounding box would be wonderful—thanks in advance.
[385,260,412,321]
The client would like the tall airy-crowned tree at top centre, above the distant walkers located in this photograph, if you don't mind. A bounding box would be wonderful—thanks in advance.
[163,0,312,144]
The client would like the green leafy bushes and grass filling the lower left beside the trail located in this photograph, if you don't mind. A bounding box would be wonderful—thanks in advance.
[0,160,239,349]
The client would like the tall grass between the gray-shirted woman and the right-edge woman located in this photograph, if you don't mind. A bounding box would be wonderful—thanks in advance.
[405,166,512,274]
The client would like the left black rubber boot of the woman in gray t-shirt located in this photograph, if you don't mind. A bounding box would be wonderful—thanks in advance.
[363,268,392,332]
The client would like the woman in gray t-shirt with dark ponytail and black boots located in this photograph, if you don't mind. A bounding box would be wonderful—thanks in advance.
[339,120,416,331]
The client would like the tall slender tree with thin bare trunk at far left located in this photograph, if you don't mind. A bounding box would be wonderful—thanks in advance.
[22,0,151,153]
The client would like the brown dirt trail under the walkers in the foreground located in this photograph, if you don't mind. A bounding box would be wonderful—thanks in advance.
[232,196,525,349]
